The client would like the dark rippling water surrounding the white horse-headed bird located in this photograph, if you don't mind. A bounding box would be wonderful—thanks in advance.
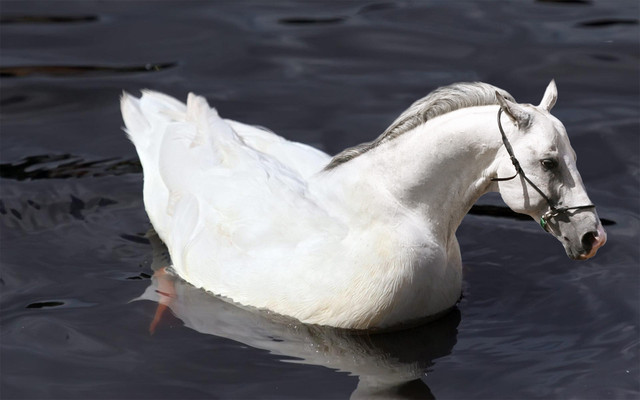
[0,0,640,399]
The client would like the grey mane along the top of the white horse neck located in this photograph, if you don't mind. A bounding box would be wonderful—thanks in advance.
[324,82,515,171]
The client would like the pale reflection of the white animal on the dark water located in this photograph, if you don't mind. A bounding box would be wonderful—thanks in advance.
[136,231,460,398]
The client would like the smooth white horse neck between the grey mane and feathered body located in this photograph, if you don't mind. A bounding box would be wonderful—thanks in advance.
[318,106,502,243]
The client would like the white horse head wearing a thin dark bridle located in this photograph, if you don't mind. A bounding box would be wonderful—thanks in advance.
[495,81,607,260]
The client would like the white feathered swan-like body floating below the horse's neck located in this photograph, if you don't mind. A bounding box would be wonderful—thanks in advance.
[122,91,461,329]
